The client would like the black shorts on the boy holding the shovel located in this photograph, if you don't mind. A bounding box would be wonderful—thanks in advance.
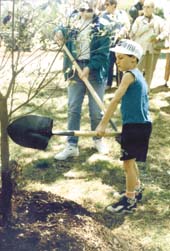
[120,123,152,162]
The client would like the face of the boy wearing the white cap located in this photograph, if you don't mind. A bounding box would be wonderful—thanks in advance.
[116,53,137,71]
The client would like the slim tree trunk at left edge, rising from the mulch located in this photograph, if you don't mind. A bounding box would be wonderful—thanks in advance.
[0,97,12,223]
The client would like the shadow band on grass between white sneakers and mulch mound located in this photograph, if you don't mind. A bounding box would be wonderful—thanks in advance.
[22,149,125,189]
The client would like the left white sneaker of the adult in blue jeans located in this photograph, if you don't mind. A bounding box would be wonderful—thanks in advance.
[54,145,79,160]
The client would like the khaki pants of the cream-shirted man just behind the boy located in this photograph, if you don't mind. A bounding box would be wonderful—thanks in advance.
[138,51,160,89]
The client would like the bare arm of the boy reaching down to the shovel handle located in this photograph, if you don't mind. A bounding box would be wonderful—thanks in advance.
[96,72,135,136]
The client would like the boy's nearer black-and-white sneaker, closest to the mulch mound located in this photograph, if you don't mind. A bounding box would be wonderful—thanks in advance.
[106,196,137,213]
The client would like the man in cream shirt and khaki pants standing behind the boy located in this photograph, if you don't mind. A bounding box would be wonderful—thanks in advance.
[130,0,167,89]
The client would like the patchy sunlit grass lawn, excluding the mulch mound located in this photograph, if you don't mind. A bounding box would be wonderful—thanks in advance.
[4,50,170,251]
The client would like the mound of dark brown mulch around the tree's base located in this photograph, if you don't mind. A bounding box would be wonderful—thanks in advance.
[0,191,142,251]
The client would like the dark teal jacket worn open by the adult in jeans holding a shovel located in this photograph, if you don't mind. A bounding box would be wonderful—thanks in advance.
[55,16,110,83]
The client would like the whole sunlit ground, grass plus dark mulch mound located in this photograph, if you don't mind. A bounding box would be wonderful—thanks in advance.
[0,46,170,251]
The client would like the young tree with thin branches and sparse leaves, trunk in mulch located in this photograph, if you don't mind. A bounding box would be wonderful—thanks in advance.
[0,0,108,223]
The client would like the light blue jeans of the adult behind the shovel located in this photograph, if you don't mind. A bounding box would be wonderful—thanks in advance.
[68,67,105,145]
